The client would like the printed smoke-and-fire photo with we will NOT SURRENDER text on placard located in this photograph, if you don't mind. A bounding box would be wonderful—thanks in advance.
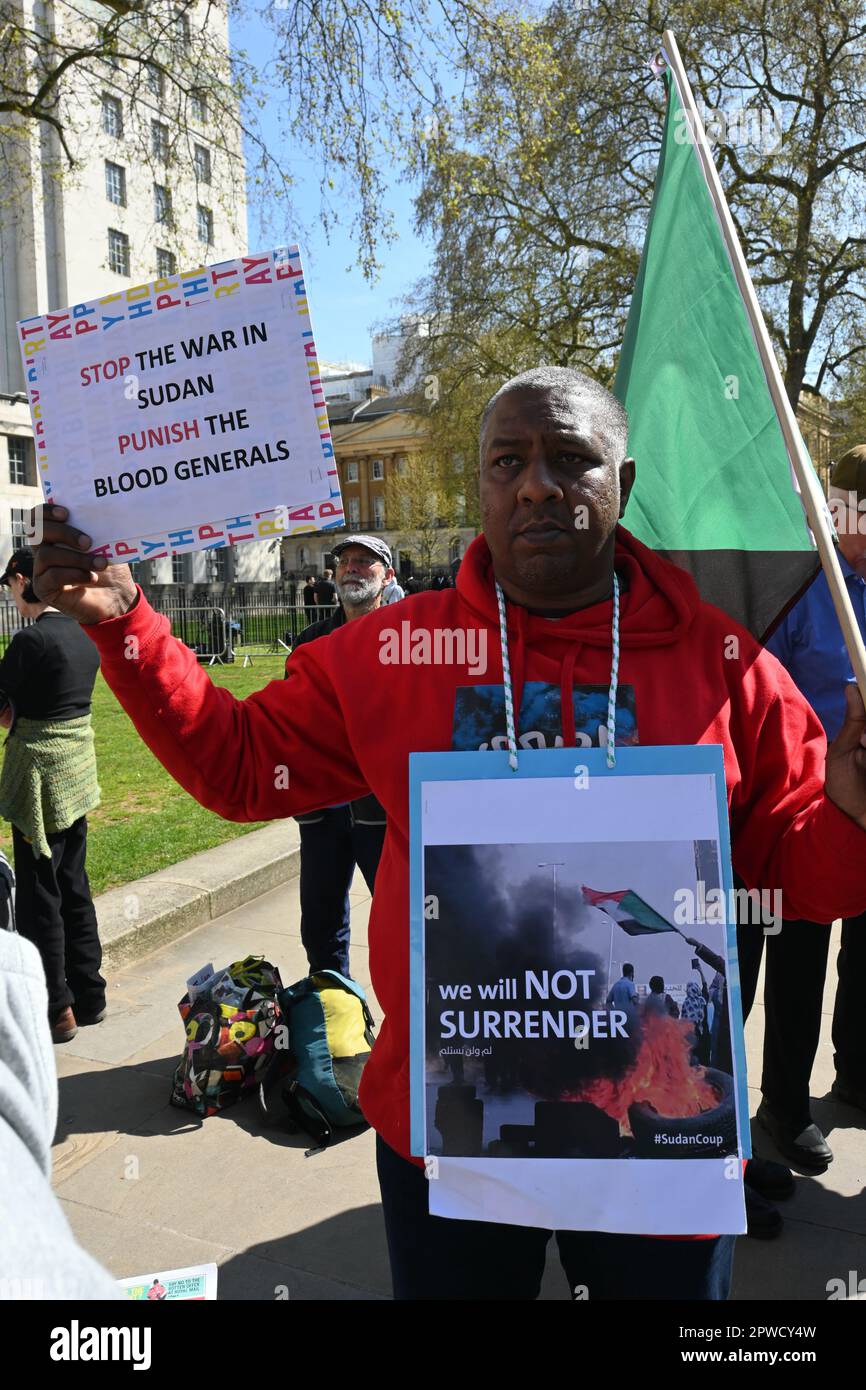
[424,840,737,1159]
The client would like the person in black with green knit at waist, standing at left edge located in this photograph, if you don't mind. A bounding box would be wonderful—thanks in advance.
[0,549,106,1043]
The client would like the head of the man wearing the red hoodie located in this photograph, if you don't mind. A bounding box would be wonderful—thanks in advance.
[480,386,634,605]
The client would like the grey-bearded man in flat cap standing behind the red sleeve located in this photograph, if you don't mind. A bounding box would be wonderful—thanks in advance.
[286,535,393,976]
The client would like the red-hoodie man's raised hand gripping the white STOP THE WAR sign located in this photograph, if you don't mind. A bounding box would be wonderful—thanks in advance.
[33,502,138,623]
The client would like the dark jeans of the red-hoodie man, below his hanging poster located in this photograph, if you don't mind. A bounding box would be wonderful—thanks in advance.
[377,1136,735,1302]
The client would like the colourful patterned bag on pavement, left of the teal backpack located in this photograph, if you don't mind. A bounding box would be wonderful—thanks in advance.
[170,956,282,1115]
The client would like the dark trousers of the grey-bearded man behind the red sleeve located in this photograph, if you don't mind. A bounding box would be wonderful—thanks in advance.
[300,806,385,976]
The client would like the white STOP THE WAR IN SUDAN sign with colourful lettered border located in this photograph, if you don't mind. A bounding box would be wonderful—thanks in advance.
[18,246,343,562]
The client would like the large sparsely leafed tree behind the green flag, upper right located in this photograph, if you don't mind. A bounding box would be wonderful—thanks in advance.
[406,0,866,430]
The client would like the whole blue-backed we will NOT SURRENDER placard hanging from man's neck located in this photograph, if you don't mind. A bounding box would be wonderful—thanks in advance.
[411,746,749,1234]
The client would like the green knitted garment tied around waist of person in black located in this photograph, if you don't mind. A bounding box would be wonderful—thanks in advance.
[0,714,99,858]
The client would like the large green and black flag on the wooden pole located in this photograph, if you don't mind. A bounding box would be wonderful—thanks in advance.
[614,72,817,638]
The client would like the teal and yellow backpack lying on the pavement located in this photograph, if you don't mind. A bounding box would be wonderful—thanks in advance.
[259,970,375,1154]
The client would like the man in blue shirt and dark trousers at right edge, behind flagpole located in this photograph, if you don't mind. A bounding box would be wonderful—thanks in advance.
[758,445,866,1172]
